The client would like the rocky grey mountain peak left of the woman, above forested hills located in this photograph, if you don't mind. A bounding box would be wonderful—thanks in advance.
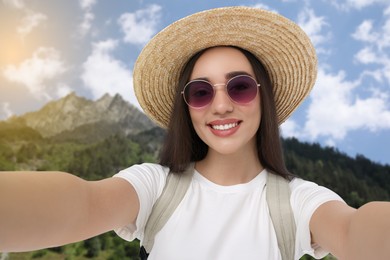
[8,93,156,142]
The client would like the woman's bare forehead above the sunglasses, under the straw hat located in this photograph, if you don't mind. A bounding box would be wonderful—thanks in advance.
[191,47,254,80]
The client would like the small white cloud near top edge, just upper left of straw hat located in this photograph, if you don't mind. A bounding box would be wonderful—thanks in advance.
[118,4,162,45]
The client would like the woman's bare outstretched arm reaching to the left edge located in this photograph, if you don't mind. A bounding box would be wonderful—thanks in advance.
[0,172,139,252]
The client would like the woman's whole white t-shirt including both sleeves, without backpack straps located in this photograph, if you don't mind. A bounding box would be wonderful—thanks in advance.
[114,163,342,260]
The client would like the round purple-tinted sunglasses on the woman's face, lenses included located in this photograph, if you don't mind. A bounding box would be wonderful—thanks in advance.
[181,75,260,109]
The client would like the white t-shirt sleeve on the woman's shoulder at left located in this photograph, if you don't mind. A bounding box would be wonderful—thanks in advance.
[113,163,169,241]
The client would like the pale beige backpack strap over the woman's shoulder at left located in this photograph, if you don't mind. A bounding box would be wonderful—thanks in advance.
[142,163,194,253]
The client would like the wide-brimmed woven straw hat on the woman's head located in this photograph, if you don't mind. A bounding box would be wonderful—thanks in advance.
[133,7,317,128]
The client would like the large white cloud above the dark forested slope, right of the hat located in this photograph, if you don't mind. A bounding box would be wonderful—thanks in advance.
[283,69,390,143]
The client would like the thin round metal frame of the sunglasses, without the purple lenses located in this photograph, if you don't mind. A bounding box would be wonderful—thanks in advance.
[181,74,261,109]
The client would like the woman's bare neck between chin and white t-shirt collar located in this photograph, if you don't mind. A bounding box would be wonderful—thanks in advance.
[195,151,263,186]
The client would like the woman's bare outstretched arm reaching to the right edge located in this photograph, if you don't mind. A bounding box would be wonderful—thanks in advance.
[310,201,390,260]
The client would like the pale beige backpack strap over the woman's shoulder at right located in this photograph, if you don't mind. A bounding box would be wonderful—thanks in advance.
[266,172,296,260]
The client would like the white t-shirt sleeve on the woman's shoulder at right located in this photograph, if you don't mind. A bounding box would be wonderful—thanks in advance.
[290,178,343,259]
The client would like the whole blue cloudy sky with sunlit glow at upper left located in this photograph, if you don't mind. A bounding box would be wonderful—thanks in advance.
[0,0,390,164]
